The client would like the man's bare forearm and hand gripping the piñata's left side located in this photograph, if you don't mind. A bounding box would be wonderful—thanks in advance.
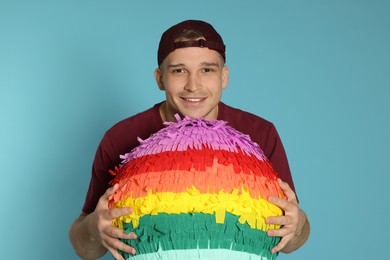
[69,185,136,260]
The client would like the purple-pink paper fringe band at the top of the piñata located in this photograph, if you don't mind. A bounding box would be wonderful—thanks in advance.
[121,116,265,165]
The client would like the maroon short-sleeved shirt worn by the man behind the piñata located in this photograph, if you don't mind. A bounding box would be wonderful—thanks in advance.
[83,102,295,214]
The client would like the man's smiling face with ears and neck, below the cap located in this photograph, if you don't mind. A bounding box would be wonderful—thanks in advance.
[155,47,228,121]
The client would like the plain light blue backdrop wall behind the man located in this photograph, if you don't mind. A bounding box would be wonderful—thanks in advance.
[0,0,390,259]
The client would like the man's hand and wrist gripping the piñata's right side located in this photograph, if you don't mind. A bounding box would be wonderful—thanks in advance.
[266,179,310,253]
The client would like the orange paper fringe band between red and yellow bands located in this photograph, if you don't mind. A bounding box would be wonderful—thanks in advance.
[110,169,284,203]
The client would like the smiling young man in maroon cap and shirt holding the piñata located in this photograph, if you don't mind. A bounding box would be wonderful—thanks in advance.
[70,20,310,259]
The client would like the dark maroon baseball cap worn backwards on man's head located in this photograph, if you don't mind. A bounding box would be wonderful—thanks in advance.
[157,20,226,66]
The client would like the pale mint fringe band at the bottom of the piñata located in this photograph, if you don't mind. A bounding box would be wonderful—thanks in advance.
[127,249,276,260]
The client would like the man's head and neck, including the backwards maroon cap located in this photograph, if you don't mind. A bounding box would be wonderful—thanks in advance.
[154,20,228,121]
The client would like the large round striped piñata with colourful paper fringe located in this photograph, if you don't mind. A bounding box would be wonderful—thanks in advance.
[109,116,285,260]
